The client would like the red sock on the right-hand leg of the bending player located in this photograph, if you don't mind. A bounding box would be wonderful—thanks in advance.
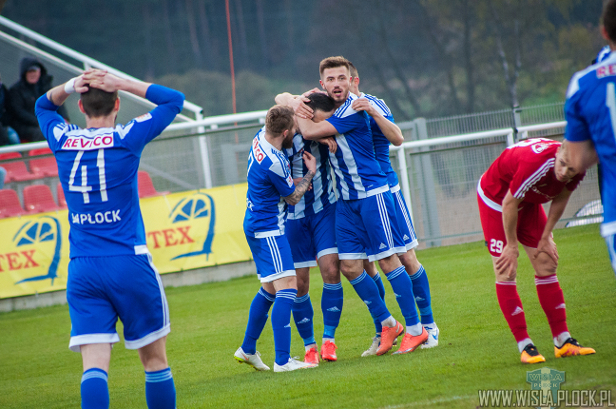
[535,274,569,338]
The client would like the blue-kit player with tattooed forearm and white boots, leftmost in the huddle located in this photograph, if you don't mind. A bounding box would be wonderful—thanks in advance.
[235,105,316,372]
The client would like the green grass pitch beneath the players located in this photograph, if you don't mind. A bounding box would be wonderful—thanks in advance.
[0,225,616,409]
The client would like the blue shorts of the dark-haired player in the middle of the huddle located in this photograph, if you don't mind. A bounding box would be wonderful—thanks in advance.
[285,203,338,268]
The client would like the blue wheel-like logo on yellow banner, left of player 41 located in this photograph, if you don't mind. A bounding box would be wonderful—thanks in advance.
[11,216,62,286]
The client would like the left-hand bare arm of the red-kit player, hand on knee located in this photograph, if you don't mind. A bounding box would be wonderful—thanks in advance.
[496,190,524,278]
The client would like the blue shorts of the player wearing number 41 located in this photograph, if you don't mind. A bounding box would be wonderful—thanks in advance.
[66,254,170,352]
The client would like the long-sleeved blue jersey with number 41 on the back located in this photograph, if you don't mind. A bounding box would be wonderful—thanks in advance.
[36,85,184,258]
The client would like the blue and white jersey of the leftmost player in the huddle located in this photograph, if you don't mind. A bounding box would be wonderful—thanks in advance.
[244,127,295,238]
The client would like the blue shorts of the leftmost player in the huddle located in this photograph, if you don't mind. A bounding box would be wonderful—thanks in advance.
[246,231,295,283]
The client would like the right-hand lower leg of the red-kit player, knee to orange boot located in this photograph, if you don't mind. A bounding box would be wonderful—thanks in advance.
[524,246,595,358]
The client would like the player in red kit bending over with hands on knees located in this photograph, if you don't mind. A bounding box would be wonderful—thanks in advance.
[477,138,595,364]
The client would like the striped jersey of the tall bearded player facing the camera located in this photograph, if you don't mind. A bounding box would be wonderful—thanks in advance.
[327,93,389,200]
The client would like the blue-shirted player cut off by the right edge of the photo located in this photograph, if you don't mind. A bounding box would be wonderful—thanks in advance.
[565,0,616,273]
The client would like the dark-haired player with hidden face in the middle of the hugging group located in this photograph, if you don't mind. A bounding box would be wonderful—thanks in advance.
[276,92,343,363]
